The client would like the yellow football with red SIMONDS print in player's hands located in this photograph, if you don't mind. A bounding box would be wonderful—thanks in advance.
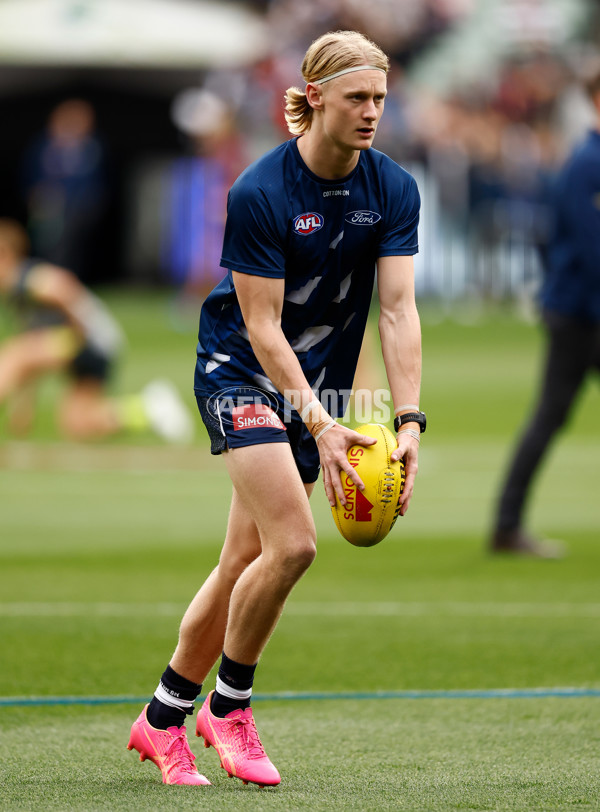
[331,423,406,547]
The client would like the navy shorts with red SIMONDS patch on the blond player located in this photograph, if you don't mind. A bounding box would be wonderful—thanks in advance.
[196,386,321,483]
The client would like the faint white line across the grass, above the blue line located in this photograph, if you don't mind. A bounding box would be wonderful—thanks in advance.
[0,601,600,619]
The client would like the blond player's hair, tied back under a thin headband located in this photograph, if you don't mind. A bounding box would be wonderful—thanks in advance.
[285,31,390,135]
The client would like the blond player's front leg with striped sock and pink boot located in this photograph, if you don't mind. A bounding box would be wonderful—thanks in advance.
[196,443,316,786]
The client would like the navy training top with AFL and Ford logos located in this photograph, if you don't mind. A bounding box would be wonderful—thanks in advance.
[194,138,420,416]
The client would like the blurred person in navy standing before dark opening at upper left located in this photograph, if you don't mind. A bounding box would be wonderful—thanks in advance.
[23,99,107,281]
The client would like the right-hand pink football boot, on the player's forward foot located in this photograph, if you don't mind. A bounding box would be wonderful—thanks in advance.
[196,691,281,787]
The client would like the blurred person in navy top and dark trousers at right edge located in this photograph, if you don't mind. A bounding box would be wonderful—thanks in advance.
[490,65,600,558]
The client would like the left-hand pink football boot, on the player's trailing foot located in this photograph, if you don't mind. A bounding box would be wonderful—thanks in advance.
[127,705,210,786]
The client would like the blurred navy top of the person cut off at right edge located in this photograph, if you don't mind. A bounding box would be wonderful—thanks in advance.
[541,131,600,323]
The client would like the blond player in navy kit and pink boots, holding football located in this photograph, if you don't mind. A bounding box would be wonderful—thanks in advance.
[129,32,425,785]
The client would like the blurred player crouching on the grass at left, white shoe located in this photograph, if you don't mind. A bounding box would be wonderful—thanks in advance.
[0,218,193,442]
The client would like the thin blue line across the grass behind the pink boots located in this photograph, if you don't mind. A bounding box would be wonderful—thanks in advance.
[0,688,600,707]
